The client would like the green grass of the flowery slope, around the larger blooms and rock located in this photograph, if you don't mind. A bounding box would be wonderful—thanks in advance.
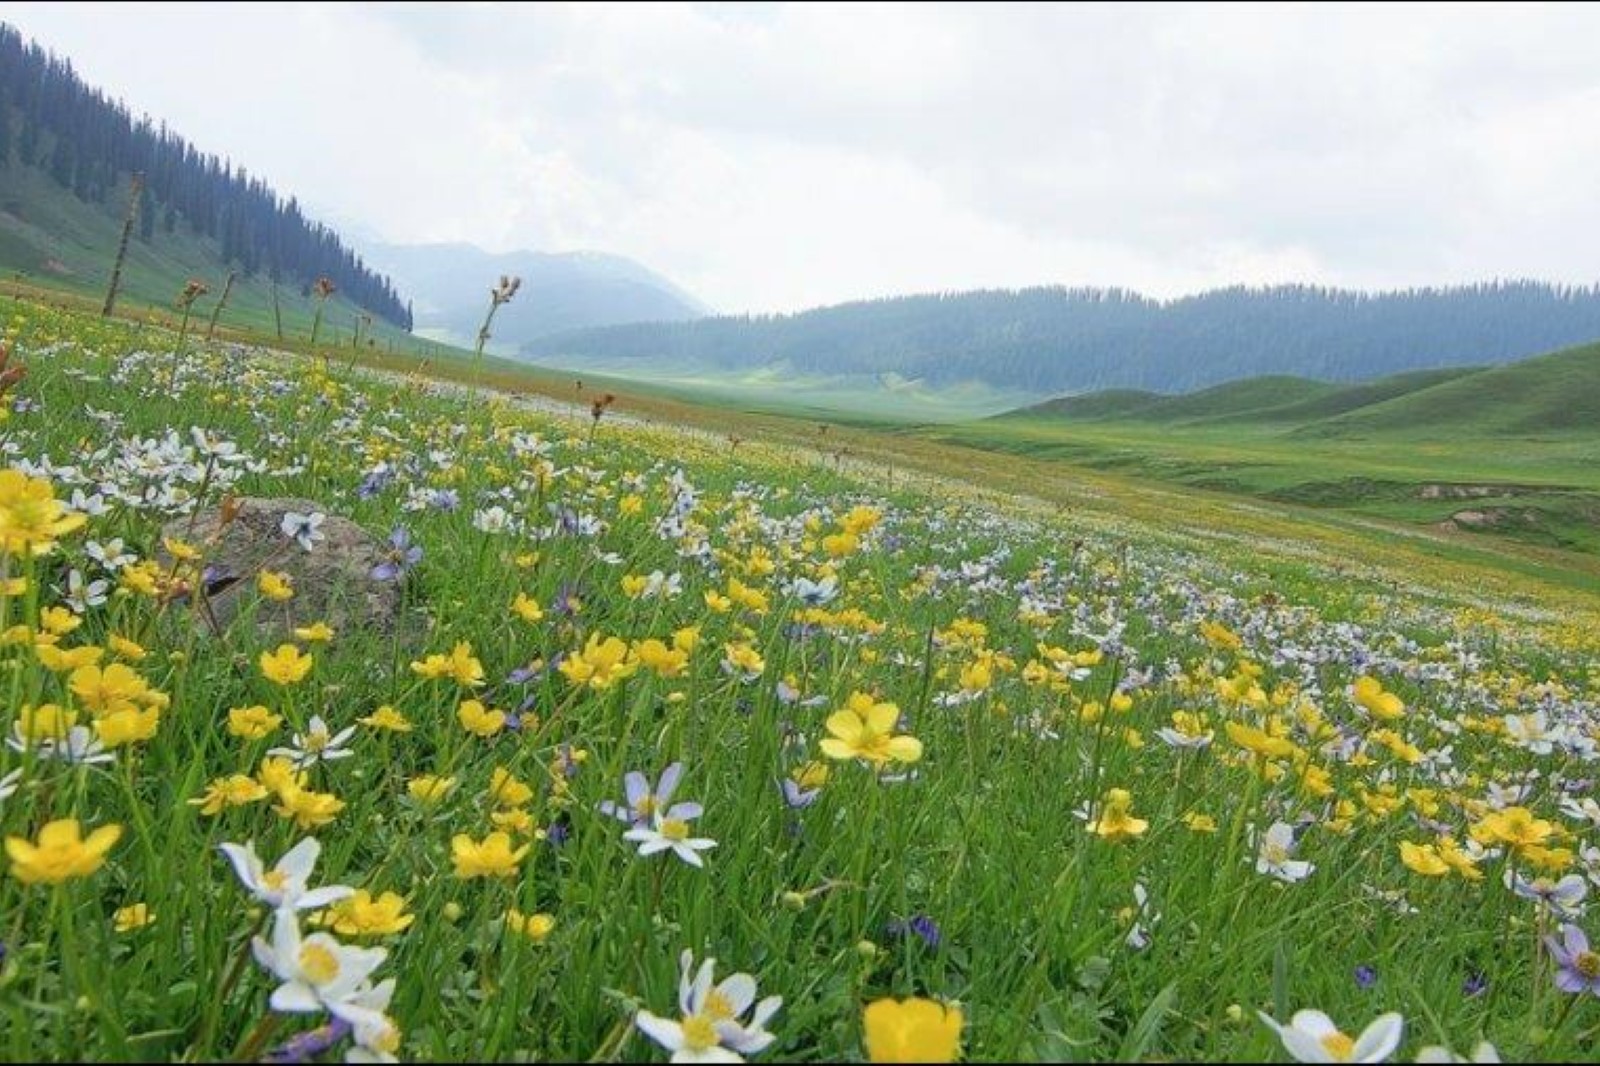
[0,292,1600,1061]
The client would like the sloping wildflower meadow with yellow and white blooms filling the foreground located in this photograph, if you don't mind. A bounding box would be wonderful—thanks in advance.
[0,292,1600,1061]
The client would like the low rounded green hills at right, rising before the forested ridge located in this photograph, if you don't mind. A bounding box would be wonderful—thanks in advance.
[989,344,1600,439]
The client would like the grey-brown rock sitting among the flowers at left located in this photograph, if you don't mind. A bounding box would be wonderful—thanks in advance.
[162,496,402,642]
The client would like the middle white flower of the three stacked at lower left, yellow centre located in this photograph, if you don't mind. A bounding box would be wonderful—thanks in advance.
[250,908,389,1026]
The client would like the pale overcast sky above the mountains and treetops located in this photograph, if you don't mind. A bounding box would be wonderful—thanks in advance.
[0,0,1600,311]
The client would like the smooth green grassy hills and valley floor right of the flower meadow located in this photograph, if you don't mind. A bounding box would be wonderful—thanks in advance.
[931,344,1600,552]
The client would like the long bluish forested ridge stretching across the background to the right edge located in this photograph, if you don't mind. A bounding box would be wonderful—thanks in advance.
[525,282,1600,394]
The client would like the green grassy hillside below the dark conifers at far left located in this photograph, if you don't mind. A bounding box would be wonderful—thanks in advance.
[0,165,413,347]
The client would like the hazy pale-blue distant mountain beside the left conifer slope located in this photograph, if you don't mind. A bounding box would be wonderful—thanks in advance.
[365,243,706,354]
